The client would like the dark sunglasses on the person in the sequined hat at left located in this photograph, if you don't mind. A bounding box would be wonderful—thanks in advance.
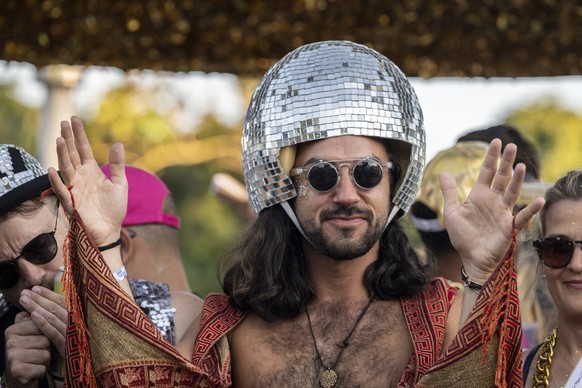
[0,202,59,290]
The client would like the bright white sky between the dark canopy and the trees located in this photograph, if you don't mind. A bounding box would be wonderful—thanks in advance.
[0,61,582,160]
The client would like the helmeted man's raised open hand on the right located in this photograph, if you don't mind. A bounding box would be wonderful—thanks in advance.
[439,139,544,282]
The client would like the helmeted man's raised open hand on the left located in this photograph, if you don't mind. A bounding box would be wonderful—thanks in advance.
[48,116,127,246]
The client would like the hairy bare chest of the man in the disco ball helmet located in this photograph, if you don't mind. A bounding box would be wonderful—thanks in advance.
[231,302,412,387]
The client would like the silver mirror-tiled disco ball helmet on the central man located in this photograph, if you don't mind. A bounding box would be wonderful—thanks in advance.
[242,41,426,217]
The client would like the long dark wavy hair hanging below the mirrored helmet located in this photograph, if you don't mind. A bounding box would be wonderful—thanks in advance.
[222,205,430,321]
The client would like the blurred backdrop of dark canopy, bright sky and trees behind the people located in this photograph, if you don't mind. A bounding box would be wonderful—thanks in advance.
[0,0,582,296]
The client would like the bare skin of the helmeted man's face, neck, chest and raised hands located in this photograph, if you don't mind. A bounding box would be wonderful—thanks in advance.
[49,117,543,387]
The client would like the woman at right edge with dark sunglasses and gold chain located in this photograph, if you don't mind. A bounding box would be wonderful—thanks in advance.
[524,170,582,387]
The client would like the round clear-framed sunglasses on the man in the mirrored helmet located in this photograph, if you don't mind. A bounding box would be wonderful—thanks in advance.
[291,158,393,193]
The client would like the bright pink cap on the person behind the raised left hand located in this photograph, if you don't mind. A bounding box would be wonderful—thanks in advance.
[101,164,180,229]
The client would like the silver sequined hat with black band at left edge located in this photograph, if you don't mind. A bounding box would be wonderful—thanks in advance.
[0,144,51,215]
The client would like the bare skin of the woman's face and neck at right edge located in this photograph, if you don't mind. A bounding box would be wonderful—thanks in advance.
[524,200,582,387]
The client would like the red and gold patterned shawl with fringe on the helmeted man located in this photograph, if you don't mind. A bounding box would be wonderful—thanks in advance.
[64,212,521,388]
